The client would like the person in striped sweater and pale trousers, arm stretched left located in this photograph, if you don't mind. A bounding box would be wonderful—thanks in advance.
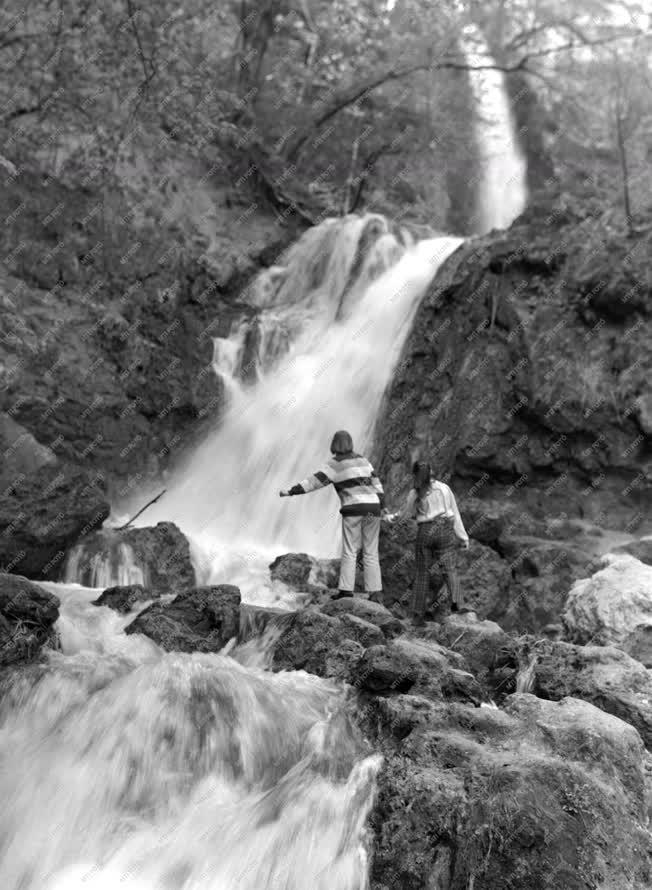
[280,430,385,600]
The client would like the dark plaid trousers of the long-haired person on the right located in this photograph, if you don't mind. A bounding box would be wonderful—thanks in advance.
[412,516,462,618]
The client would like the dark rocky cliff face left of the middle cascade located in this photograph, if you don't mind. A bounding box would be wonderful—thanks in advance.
[0,171,294,496]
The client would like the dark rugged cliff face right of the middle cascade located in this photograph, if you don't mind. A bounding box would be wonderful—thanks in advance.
[376,198,652,533]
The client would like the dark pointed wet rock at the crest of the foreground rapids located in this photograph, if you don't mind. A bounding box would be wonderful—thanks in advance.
[125,584,240,652]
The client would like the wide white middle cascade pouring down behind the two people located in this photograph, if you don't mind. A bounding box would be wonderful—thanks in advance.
[138,214,462,583]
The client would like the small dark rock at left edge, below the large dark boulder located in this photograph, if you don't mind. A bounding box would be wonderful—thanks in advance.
[0,572,59,667]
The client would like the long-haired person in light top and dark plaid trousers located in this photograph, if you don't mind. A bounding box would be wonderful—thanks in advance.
[387,461,469,625]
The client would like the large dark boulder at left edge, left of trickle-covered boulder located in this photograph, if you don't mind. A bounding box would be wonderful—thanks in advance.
[0,460,110,581]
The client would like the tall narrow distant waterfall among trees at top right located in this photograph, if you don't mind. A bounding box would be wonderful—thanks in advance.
[464,25,527,234]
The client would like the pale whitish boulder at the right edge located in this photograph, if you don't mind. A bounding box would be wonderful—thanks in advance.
[563,554,652,667]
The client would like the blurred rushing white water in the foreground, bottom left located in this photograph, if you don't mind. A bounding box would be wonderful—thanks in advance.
[0,585,380,890]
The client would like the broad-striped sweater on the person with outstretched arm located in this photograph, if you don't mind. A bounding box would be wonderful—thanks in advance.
[289,451,385,516]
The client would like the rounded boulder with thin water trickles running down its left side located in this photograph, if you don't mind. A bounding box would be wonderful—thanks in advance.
[66,522,197,596]
